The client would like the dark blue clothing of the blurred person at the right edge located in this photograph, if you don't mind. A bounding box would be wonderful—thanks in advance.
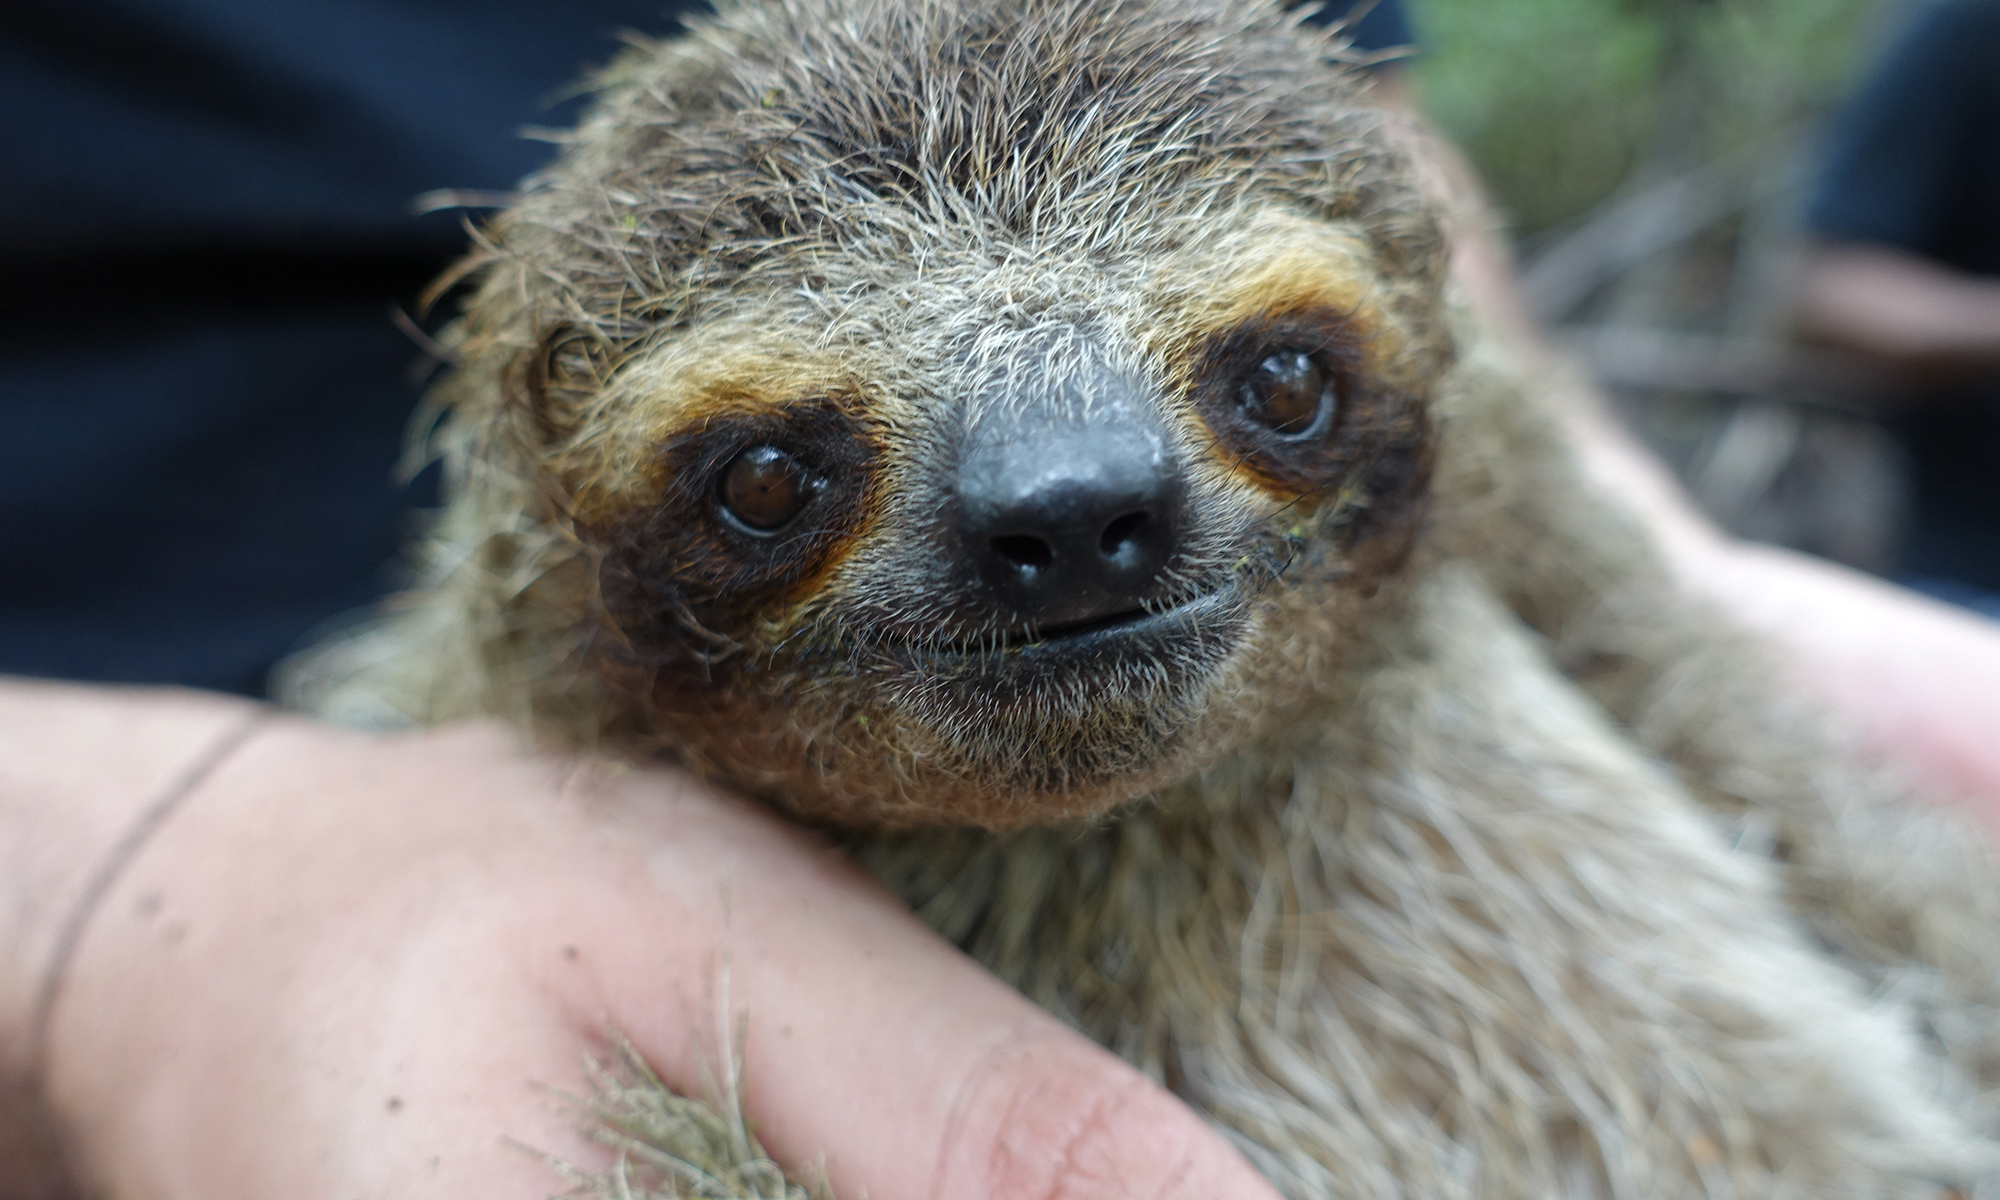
[1808,0,2000,592]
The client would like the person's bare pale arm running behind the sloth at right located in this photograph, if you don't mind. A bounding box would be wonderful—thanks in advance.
[1376,70,2000,832]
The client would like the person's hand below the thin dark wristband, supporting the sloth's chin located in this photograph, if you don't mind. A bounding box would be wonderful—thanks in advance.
[0,688,1272,1200]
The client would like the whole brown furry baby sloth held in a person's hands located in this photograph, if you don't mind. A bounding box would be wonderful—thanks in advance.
[306,0,2000,1200]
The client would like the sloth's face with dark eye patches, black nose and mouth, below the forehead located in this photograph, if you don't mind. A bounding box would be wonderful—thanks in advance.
[532,214,1428,824]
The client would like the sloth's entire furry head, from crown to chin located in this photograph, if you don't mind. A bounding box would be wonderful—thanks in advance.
[430,0,1450,826]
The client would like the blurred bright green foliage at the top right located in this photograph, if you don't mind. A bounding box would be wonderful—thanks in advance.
[1412,0,1882,234]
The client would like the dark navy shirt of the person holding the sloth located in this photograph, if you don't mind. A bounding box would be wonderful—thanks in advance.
[0,0,1410,694]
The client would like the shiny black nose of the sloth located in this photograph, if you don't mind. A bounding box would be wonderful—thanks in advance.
[956,390,1186,626]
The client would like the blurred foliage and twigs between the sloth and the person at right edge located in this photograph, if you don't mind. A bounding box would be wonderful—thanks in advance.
[1410,0,1920,572]
